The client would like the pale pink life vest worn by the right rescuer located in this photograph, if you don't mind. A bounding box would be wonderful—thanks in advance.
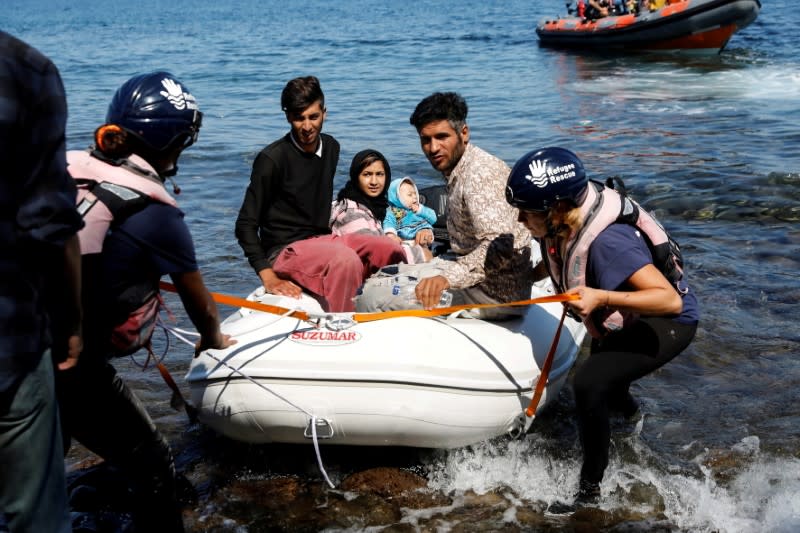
[541,180,685,338]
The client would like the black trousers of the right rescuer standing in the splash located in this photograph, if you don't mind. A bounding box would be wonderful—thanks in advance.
[573,317,697,483]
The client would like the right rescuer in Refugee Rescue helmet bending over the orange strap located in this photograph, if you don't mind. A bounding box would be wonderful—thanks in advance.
[506,147,700,505]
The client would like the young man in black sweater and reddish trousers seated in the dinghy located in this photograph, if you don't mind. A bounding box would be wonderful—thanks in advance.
[236,76,405,312]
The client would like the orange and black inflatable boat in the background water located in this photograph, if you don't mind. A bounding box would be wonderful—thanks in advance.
[536,0,761,53]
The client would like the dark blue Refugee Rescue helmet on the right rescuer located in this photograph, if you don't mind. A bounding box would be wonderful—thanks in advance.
[506,147,587,211]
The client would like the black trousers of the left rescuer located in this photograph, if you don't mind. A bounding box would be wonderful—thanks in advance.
[56,352,183,532]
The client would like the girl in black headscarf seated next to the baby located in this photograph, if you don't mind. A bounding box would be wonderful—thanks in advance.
[330,149,433,264]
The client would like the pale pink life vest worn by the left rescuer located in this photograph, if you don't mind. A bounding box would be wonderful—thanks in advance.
[67,150,177,255]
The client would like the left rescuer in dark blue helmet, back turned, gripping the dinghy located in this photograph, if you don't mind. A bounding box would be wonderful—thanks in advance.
[57,71,235,533]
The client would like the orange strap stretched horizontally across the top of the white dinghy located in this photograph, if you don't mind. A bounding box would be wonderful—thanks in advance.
[159,281,580,322]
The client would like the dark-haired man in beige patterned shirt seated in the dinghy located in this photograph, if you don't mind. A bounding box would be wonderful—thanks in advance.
[410,92,532,318]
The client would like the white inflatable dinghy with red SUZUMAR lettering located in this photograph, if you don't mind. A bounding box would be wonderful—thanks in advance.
[186,280,585,448]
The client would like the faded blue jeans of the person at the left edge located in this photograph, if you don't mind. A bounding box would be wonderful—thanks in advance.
[0,350,72,533]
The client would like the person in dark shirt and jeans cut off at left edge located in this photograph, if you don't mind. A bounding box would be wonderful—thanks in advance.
[0,31,82,533]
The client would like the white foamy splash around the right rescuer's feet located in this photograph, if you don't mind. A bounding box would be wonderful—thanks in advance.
[429,435,800,533]
